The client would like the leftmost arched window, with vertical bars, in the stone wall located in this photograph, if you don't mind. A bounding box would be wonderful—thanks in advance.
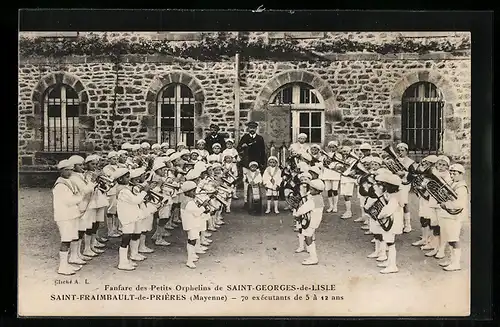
[42,84,80,152]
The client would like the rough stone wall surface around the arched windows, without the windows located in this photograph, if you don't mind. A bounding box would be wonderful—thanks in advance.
[18,33,471,164]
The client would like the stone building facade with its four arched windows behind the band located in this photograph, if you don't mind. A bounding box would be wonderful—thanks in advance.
[18,32,471,167]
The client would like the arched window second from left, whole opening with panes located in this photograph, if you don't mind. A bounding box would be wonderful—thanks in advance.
[157,83,194,147]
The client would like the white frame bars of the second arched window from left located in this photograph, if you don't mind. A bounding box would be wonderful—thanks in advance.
[156,83,196,146]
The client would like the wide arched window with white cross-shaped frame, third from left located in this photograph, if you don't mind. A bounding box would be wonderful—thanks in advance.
[271,83,325,144]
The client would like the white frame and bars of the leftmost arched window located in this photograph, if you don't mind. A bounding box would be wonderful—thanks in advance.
[43,84,80,152]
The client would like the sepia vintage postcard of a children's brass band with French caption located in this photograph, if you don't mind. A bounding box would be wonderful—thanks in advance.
[18,26,471,317]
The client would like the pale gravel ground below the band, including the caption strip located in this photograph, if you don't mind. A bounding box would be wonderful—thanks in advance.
[19,189,470,316]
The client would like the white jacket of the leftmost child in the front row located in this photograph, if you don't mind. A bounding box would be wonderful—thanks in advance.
[52,177,83,221]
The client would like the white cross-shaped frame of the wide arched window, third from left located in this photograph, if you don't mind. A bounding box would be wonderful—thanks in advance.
[270,83,325,146]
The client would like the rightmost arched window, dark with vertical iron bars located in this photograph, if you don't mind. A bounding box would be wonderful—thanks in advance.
[401,82,444,153]
